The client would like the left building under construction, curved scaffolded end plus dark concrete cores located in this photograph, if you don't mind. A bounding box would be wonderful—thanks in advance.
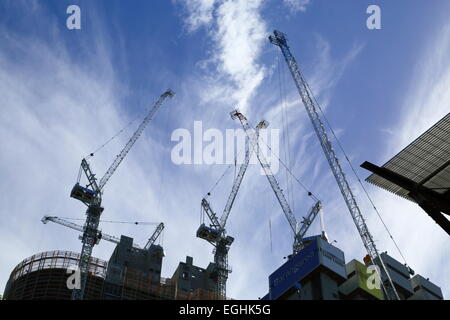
[4,236,217,300]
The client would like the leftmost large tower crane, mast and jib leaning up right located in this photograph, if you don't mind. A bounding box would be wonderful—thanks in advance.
[70,90,174,300]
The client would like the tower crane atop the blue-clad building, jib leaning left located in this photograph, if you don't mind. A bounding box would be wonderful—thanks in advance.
[230,110,322,254]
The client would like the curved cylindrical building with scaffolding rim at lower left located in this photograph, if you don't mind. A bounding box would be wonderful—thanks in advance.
[3,251,107,300]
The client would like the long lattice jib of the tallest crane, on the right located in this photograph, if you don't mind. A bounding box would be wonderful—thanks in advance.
[269,30,400,300]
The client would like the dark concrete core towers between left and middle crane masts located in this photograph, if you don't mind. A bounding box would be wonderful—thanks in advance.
[103,236,215,300]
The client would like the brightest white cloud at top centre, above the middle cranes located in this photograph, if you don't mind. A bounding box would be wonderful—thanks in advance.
[177,0,267,111]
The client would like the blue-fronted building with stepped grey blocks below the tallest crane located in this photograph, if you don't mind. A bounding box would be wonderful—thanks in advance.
[262,236,443,300]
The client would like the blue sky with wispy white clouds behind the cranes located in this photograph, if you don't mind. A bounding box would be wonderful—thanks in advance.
[0,0,450,299]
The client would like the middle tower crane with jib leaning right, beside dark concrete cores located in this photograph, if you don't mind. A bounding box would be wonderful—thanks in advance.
[197,121,269,300]
